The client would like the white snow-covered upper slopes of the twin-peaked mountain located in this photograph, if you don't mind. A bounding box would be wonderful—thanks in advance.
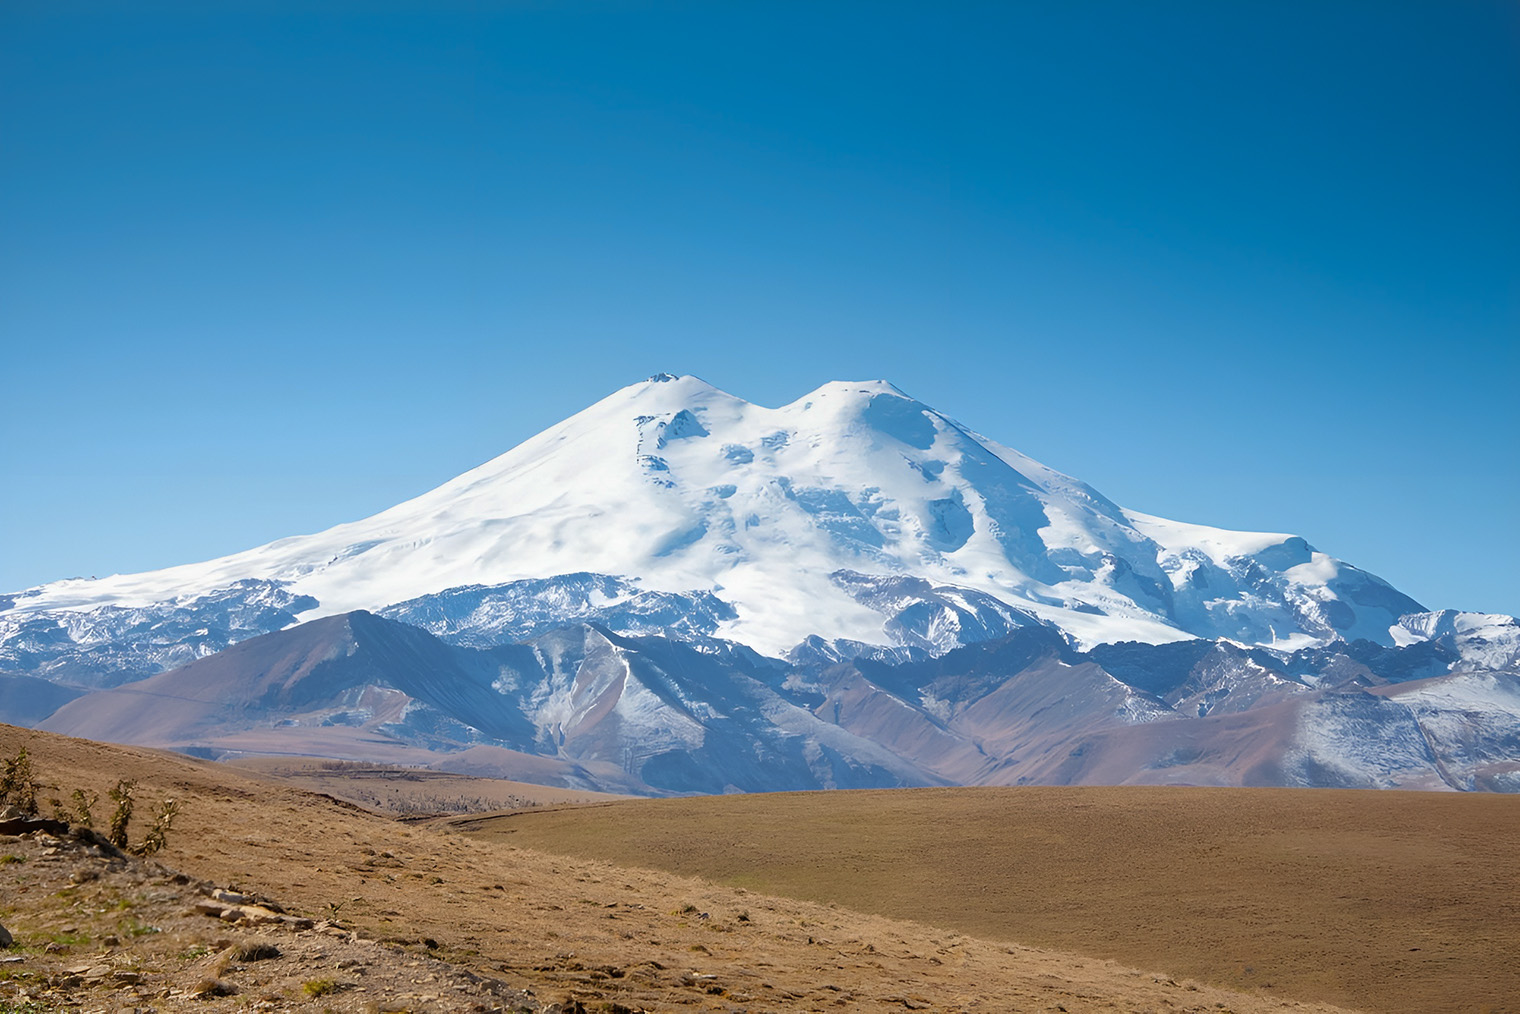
[0,374,1423,654]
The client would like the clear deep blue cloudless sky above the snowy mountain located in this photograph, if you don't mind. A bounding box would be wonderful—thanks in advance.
[0,0,1520,613]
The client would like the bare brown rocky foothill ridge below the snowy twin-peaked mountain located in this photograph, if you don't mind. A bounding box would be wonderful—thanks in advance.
[32,611,1520,795]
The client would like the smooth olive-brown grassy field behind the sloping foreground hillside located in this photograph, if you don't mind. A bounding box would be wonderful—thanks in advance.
[454,787,1520,1014]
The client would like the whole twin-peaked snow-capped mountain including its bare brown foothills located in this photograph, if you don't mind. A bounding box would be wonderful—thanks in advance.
[0,374,1520,792]
